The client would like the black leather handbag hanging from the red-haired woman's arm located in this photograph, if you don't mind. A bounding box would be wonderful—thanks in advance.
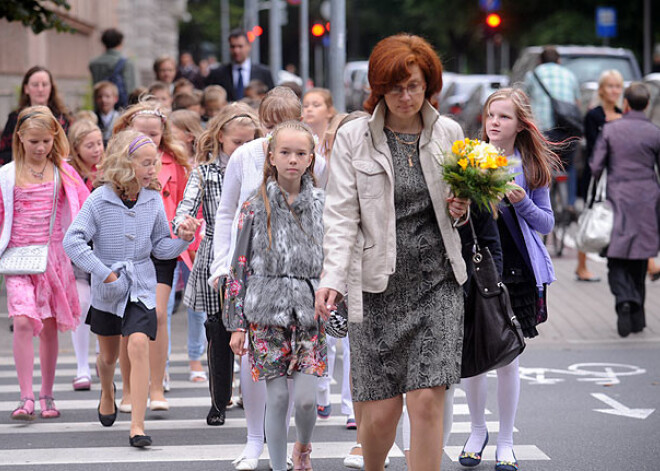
[461,220,525,378]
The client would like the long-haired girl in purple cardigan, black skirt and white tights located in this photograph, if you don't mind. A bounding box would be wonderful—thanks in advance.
[456,88,559,471]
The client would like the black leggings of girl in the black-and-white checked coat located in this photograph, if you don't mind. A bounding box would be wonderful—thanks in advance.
[209,306,234,412]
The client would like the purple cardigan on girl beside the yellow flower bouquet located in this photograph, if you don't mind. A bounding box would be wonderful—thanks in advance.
[506,149,556,287]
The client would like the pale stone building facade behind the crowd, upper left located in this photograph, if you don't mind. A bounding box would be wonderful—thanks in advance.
[0,0,187,123]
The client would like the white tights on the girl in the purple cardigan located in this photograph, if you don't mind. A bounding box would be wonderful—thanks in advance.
[461,358,520,461]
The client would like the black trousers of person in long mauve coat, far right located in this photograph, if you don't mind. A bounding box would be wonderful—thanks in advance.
[607,258,648,327]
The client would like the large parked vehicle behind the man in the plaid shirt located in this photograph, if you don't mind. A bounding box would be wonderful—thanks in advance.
[511,46,642,113]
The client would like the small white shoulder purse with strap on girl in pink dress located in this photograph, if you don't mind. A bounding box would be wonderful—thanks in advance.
[0,167,59,275]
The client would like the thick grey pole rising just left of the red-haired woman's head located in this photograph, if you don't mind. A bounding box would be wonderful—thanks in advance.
[329,0,346,112]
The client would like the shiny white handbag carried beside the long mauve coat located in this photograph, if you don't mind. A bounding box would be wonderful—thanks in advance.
[575,171,614,253]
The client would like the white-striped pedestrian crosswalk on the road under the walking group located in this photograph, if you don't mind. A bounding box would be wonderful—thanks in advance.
[0,354,550,471]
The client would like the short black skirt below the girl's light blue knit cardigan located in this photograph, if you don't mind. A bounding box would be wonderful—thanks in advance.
[85,301,158,340]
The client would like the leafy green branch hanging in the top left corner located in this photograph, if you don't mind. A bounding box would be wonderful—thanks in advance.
[0,0,75,34]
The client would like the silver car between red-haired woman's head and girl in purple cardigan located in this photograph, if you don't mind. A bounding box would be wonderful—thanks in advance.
[438,74,509,138]
